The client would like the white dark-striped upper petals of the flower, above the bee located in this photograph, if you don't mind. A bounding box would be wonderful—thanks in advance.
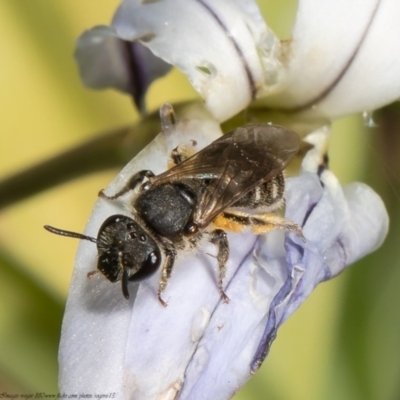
[77,0,400,121]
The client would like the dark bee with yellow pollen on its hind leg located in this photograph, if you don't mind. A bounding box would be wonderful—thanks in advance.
[45,124,304,306]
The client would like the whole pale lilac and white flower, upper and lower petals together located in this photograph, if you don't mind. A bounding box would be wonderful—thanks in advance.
[60,0,400,399]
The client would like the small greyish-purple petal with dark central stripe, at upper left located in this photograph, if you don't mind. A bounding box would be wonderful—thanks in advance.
[75,26,172,111]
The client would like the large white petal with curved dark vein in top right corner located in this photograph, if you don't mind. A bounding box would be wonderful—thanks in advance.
[265,0,400,118]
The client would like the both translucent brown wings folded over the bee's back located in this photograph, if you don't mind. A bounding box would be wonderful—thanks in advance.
[154,124,300,227]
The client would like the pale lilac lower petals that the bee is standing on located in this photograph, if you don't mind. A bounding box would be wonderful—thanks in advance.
[60,120,388,400]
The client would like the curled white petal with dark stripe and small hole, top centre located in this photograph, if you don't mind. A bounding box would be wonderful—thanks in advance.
[112,0,279,120]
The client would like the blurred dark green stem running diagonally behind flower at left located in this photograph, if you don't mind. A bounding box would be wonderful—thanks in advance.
[0,117,160,209]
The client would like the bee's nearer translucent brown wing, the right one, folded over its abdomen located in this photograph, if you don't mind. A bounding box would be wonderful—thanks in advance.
[193,124,300,227]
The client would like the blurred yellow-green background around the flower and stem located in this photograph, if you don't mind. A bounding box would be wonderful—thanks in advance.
[0,0,400,400]
